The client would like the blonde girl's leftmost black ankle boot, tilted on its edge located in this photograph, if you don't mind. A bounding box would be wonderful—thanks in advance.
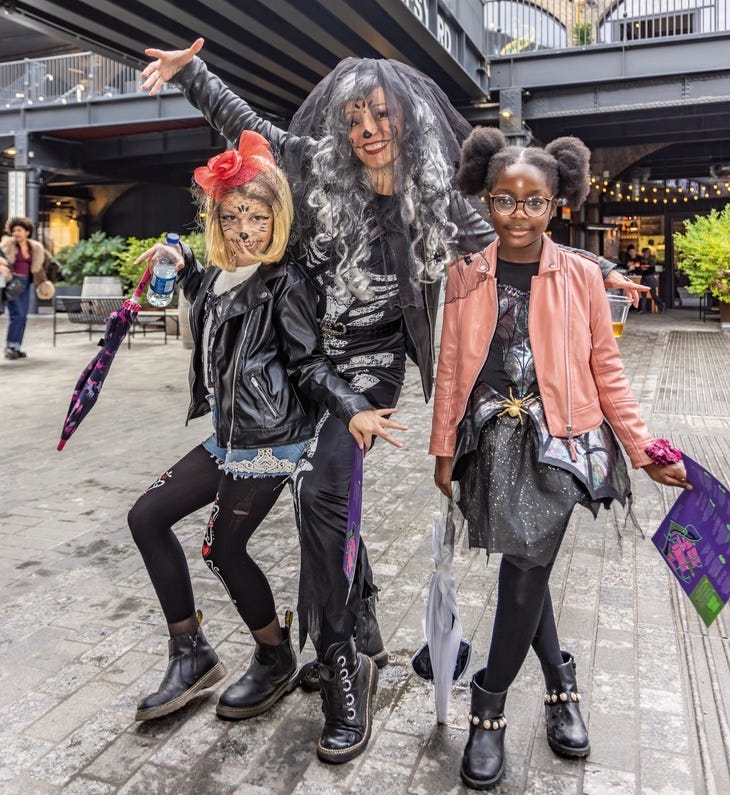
[135,627,226,720]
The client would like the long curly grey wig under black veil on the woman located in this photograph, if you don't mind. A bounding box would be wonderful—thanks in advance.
[290,58,470,299]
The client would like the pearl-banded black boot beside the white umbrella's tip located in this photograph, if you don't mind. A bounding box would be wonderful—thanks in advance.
[461,668,507,790]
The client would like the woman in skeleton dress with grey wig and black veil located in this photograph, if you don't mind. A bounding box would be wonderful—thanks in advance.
[142,39,644,763]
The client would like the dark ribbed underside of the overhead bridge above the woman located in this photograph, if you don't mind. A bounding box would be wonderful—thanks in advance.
[5,0,485,111]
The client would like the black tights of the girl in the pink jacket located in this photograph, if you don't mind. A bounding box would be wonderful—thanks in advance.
[481,558,563,693]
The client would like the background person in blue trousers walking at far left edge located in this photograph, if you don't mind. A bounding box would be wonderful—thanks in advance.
[0,216,48,360]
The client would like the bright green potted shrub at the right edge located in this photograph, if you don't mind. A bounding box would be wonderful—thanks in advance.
[673,204,730,327]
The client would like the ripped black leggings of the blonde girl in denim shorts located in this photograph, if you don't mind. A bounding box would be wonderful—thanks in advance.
[128,445,287,631]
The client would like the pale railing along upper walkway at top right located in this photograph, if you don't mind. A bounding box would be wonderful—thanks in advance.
[484,0,730,58]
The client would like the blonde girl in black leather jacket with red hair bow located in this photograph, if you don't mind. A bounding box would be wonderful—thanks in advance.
[128,132,404,720]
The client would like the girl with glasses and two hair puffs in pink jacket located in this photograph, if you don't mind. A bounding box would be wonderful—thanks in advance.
[429,128,691,789]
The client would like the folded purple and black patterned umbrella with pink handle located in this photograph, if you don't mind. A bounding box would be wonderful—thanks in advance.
[56,269,150,450]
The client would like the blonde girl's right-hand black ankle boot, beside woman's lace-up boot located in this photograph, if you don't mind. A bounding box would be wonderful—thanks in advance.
[215,614,298,720]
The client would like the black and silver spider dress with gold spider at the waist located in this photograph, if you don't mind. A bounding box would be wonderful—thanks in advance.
[453,261,630,569]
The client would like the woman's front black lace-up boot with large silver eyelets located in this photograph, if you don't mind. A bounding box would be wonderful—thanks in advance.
[317,639,378,765]
